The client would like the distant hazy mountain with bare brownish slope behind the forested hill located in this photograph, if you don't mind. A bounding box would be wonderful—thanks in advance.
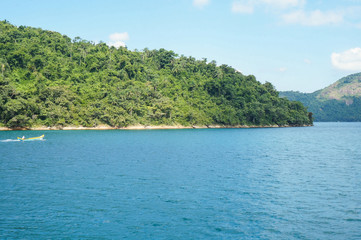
[280,73,361,122]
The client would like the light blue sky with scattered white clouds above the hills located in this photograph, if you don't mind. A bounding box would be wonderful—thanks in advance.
[0,0,361,92]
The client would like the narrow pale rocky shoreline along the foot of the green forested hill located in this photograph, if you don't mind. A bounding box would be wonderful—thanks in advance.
[0,124,313,131]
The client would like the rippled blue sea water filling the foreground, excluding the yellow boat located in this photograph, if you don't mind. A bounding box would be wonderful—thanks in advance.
[0,123,361,239]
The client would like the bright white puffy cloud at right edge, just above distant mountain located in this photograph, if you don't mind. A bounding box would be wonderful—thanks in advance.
[331,48,361,71]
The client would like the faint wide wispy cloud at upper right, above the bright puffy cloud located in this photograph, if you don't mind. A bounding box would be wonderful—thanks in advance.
[282,10,344,26]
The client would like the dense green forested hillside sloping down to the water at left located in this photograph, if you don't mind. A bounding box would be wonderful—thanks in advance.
[0,21,312,127]
